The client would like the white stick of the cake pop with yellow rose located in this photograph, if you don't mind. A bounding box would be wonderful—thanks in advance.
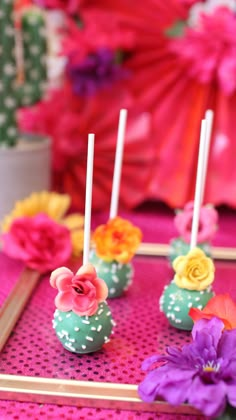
[190,120,207,250]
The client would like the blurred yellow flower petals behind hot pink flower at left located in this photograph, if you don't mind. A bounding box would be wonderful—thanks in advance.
[1,191,84,257]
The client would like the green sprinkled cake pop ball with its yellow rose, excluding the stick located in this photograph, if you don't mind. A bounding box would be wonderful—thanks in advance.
[160,248,215,331]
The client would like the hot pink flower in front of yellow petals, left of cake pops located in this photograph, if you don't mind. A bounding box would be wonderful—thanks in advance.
[3,214,72,273]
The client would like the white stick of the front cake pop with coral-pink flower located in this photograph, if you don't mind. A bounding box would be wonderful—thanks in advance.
[83,134,95,265]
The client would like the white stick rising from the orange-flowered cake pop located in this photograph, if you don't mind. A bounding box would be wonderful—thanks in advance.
[110,109,127,219]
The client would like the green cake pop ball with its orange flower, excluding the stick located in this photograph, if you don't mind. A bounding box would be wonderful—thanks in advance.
[90,216,142,298]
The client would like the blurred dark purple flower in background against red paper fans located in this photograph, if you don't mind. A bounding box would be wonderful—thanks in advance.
[67,48,128,96]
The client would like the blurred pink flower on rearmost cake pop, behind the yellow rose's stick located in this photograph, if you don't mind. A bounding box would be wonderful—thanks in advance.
[174,201,218,243]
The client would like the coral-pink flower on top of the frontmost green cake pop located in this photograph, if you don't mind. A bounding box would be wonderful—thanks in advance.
[50,264,108,316]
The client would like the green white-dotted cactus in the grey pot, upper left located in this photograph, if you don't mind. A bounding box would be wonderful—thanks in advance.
[0,0,47,147]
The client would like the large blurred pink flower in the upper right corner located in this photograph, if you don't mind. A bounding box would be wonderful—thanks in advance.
[170,7,236,94]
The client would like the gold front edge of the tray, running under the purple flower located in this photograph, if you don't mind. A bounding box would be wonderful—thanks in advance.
[0,374,199,415]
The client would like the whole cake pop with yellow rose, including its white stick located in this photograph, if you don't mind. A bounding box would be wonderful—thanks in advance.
[160,116,215,330]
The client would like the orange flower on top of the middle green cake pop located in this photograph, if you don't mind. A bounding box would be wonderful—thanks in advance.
[93,217,142,263]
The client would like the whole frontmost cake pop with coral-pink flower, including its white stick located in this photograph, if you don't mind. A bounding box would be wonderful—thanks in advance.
[50,134,114,353]
